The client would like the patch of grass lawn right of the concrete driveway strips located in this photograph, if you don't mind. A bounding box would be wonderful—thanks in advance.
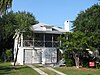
[55,67,100,75]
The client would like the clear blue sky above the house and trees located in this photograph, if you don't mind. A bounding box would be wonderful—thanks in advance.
[12,0,98,28]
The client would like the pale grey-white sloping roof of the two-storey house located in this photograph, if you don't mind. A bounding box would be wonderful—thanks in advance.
[32,23,66,34]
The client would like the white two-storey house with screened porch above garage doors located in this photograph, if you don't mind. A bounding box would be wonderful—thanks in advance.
[14,23,69,65]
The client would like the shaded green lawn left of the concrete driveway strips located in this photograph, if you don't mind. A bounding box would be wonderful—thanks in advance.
[0,63,39,75]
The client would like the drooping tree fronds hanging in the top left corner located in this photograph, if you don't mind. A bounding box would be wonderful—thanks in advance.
[0,0,13,16]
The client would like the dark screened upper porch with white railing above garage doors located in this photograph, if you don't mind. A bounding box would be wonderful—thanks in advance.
[23,33,61,47]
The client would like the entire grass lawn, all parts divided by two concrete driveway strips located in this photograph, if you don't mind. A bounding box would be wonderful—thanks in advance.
[0,63,100,75]
